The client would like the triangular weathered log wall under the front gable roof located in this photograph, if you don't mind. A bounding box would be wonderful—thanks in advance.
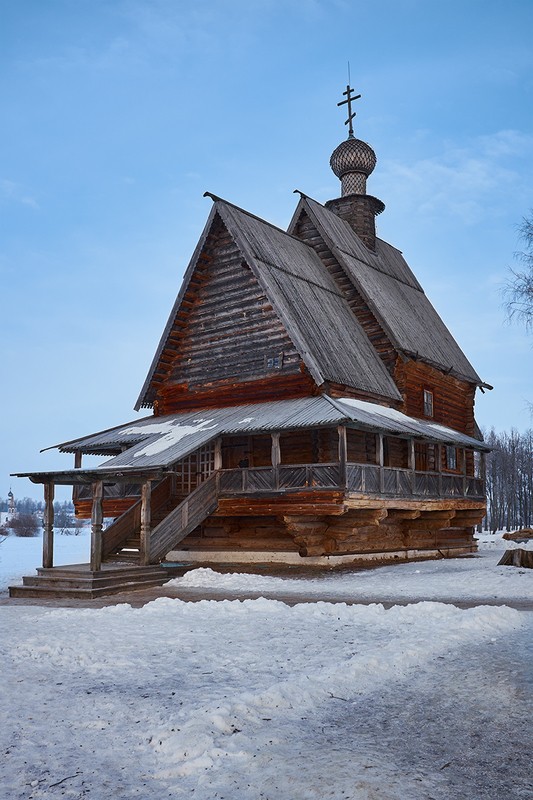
[154,219,311,414]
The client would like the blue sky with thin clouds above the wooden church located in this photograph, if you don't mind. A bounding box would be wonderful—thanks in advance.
[0,0,533,497]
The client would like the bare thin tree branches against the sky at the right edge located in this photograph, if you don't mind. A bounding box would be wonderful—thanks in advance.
[503,210,533,333]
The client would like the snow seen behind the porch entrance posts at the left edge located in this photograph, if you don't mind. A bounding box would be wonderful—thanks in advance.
[0,527,91,594]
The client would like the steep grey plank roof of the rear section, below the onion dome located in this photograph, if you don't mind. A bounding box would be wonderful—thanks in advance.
[289,196,484,386]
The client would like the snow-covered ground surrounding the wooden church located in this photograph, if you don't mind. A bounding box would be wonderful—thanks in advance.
[0,536,533,800]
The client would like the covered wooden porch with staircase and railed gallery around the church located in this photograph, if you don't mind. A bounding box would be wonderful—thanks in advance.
[9,398,487,596]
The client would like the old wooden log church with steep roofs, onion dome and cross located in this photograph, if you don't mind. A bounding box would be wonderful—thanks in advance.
[12,87,490,596]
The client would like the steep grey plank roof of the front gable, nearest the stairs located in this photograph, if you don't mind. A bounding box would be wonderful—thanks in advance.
[135,194,401,410]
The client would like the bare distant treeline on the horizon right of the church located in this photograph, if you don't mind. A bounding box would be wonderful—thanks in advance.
[485,429,533,531]
